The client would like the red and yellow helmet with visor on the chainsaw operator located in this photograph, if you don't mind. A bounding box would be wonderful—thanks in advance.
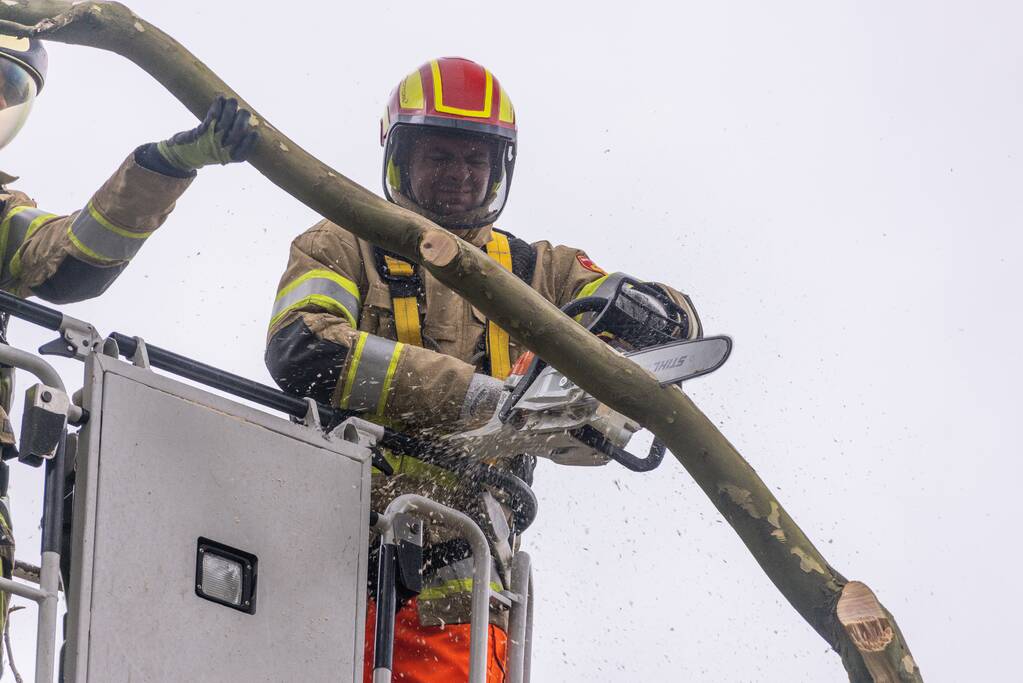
[381,57,517,230]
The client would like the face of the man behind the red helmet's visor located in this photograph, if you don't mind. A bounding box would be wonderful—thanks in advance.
[408,133,491,216]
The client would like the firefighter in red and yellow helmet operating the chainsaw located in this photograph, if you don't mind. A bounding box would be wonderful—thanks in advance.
[266,58,700,683]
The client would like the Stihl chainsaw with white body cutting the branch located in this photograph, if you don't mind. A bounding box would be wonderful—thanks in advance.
[442,275,731,471]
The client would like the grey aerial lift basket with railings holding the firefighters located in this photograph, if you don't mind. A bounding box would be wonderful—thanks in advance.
[0,292,535,683]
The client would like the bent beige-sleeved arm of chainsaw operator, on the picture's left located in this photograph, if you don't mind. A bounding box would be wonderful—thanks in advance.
[266,221,501,428]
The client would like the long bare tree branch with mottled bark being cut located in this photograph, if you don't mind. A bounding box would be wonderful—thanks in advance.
[0,0,923,682]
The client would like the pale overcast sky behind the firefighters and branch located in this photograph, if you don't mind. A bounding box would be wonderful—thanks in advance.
[7,0,1023,683]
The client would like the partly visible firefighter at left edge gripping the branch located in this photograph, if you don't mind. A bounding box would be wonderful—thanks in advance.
[0,35,257,646]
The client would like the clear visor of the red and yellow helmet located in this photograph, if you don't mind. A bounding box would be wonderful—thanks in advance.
[384,125,515,230]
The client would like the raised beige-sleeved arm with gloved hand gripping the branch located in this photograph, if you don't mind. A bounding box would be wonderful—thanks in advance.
[0,98,256,304]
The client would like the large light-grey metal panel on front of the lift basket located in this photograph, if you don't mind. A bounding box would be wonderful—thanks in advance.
[69,358,369,682]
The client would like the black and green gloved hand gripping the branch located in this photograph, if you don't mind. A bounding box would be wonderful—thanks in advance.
[157,96,259,173]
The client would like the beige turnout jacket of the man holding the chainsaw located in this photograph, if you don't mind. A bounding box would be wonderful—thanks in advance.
[266,221,699,624]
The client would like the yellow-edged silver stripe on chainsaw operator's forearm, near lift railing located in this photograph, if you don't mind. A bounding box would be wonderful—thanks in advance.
[340,332,405,415]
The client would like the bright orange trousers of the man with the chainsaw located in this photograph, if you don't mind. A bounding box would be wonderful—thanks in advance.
[362,599,508,683]
